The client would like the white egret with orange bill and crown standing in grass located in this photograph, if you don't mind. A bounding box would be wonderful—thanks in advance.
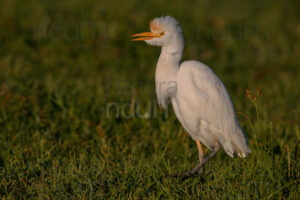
[132,16,250,175]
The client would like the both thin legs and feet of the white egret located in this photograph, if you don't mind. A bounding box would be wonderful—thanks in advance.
[182,140,220,176]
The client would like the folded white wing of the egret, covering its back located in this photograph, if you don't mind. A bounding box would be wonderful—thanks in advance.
[177,61,250,157]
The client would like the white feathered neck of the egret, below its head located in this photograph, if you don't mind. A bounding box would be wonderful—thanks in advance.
[155,45,183,108]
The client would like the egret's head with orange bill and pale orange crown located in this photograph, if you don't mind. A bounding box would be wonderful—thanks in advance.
[132,16,183,46]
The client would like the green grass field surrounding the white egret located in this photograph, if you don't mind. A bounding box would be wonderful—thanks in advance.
[0,0,300,199]
